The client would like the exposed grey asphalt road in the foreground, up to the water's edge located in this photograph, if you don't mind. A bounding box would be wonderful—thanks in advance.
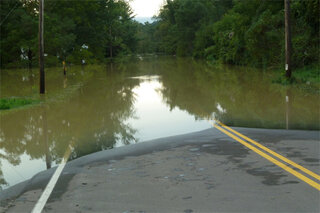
[0,123,320,212]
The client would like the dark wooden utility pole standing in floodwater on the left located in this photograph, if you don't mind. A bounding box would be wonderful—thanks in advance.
[39,0,45,94]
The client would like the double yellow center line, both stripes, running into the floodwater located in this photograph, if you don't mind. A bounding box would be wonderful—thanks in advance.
[212,120,320,191]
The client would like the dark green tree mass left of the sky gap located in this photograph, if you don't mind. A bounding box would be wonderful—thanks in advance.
[0,0,137,67]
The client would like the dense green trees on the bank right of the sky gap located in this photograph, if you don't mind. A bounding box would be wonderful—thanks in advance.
[142,0,320,67]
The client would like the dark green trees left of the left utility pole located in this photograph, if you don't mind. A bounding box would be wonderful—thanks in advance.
[0,0,37,67]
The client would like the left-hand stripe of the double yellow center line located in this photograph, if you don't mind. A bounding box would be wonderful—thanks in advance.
[214,124,320,191]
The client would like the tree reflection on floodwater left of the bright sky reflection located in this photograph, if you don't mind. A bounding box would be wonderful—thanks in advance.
[0,67,139,188]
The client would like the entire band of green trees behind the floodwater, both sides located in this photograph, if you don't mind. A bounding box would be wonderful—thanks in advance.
[0,0,320,84]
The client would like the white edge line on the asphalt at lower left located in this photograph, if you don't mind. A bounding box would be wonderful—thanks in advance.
[31,147,70,213]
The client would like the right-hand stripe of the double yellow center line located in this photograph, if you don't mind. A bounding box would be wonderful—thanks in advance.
[216,121,320,180]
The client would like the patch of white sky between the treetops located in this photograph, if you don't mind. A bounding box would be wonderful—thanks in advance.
[130,0,164,17]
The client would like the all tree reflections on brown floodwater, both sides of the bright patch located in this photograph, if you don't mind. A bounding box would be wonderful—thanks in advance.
[0,58,320,189]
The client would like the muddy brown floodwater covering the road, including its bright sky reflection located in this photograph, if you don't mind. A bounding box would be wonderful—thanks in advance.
[0,57,320,188]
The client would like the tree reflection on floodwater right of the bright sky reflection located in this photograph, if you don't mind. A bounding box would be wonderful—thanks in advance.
[159,59,320,129]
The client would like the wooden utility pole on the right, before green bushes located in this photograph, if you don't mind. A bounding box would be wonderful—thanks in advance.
[284,0,292,78]
